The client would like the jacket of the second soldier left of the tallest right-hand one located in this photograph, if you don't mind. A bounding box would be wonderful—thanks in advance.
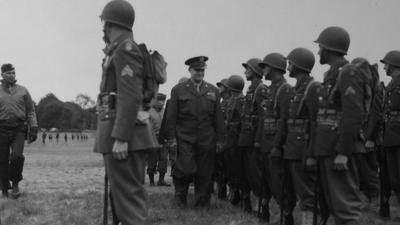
[256,77,292,152]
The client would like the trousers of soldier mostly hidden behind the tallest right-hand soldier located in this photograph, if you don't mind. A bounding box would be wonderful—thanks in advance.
[356,151,379,199]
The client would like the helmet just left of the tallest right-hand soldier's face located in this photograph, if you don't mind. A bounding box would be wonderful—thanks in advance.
[286,48,315,72]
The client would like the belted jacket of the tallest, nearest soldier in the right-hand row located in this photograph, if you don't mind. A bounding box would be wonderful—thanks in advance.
[313,59,366,156]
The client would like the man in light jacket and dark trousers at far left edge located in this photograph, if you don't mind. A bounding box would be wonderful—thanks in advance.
[0,64,38,198]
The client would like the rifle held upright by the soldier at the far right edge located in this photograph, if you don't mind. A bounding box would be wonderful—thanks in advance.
[377,145,391,219]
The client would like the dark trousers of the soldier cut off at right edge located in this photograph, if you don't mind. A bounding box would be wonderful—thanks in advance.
[385,146,400,198]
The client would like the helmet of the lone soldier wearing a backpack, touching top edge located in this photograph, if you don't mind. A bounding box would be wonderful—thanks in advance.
[100,0,135,30]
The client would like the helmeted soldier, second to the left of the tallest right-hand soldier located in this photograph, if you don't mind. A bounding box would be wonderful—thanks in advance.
[255,53,294,224]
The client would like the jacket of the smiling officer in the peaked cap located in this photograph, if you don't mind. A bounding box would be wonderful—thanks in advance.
[166,80,224,145]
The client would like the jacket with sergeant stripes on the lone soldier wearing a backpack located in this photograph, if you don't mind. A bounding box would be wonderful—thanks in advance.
[94,33,157,153]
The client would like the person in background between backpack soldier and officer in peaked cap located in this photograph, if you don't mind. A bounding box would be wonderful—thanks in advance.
[147,93,171,186]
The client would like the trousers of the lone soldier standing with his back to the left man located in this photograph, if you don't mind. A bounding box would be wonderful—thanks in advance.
[103,150,147,225]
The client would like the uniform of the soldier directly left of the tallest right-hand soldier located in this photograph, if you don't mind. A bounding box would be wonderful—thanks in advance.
[283,76,318,211]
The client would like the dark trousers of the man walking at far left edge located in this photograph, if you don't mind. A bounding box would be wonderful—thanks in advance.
[0,125,26,190]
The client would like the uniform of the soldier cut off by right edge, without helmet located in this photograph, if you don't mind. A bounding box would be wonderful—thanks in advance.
[383,71,400,202]
